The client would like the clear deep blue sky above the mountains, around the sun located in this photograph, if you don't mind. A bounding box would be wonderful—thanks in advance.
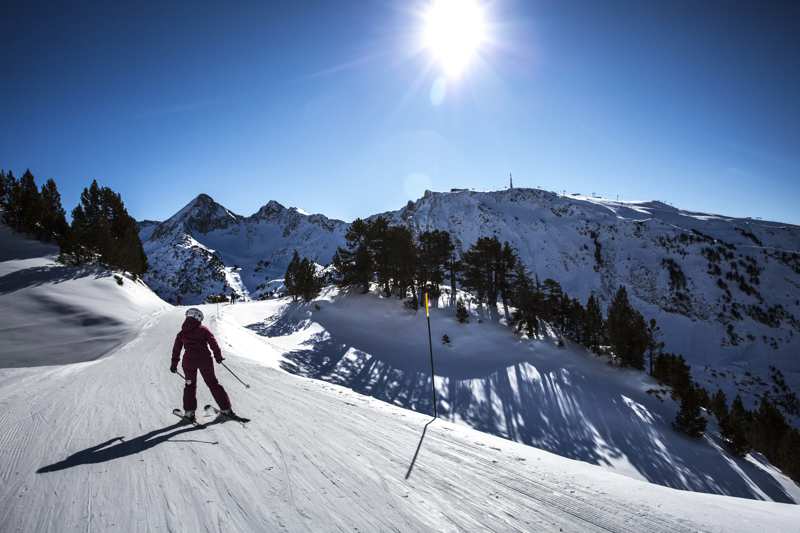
[0,0,800,223]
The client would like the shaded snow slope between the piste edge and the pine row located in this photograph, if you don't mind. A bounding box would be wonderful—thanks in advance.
[226,295,800,503]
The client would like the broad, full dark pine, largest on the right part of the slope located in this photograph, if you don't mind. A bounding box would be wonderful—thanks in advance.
[608,286,649,370]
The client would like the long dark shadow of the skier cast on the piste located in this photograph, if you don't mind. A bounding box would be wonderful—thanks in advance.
[36,420,220,474]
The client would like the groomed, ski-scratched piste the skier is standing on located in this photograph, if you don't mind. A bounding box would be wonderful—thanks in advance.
[0,308,800,532]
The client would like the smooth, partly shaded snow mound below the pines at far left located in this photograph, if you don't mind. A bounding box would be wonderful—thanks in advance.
[0,224,167,368]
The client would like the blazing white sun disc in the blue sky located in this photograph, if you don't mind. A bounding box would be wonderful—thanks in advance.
[423,0,486,78]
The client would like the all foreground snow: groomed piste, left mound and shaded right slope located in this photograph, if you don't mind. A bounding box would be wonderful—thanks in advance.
[0,215,800,532]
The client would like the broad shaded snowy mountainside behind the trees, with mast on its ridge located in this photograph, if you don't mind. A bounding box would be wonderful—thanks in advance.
[376,189,800,406]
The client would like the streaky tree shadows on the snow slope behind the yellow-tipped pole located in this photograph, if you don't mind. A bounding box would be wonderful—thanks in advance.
[260,304,795,503]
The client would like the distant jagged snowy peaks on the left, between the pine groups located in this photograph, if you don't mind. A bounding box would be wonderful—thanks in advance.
[140,194,347,304]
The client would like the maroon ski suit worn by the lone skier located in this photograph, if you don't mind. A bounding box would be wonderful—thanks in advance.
[172,317,231,411]
